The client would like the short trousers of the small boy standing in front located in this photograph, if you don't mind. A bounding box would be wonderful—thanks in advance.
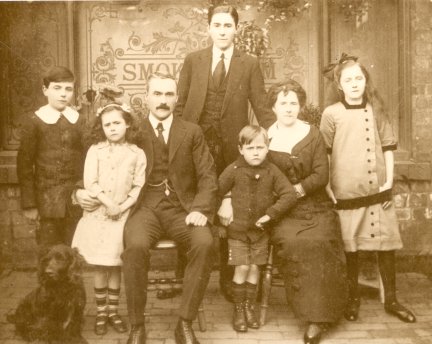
[228,235,269,265]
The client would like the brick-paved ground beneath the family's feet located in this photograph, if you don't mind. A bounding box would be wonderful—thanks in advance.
[0,271,432,344]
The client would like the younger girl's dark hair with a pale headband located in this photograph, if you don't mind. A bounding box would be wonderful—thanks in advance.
[86,103,140,145]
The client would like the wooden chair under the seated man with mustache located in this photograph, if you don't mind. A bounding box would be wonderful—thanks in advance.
[147,239,207,332]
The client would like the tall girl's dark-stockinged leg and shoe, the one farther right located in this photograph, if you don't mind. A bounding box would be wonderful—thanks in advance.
[378,251,416,323]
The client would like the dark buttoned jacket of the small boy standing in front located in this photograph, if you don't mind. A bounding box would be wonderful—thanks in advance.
[219,156,297,242]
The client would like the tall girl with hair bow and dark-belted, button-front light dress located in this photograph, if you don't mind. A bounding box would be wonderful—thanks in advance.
[320,54,416,323]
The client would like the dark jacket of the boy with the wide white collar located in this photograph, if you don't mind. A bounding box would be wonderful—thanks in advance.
[17,114,85,218]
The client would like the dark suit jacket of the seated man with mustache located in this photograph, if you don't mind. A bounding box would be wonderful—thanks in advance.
[132,118,218,222]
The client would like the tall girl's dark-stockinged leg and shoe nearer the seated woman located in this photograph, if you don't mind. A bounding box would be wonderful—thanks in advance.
[344,252,360,321]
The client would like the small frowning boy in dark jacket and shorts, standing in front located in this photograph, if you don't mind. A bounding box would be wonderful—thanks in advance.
[219,125,296,332]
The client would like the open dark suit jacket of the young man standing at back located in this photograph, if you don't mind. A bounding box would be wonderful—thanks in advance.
[174,47,276,163]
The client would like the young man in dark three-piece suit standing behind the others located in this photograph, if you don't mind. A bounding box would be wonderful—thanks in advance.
[174,6,275,298]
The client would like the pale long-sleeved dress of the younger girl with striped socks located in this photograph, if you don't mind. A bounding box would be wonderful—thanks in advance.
[72,141,147,266]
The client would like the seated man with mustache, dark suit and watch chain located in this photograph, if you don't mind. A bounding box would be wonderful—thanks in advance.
[77,73,217,344]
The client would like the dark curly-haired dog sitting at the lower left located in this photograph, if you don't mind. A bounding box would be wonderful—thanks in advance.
[8,245,87,344]
